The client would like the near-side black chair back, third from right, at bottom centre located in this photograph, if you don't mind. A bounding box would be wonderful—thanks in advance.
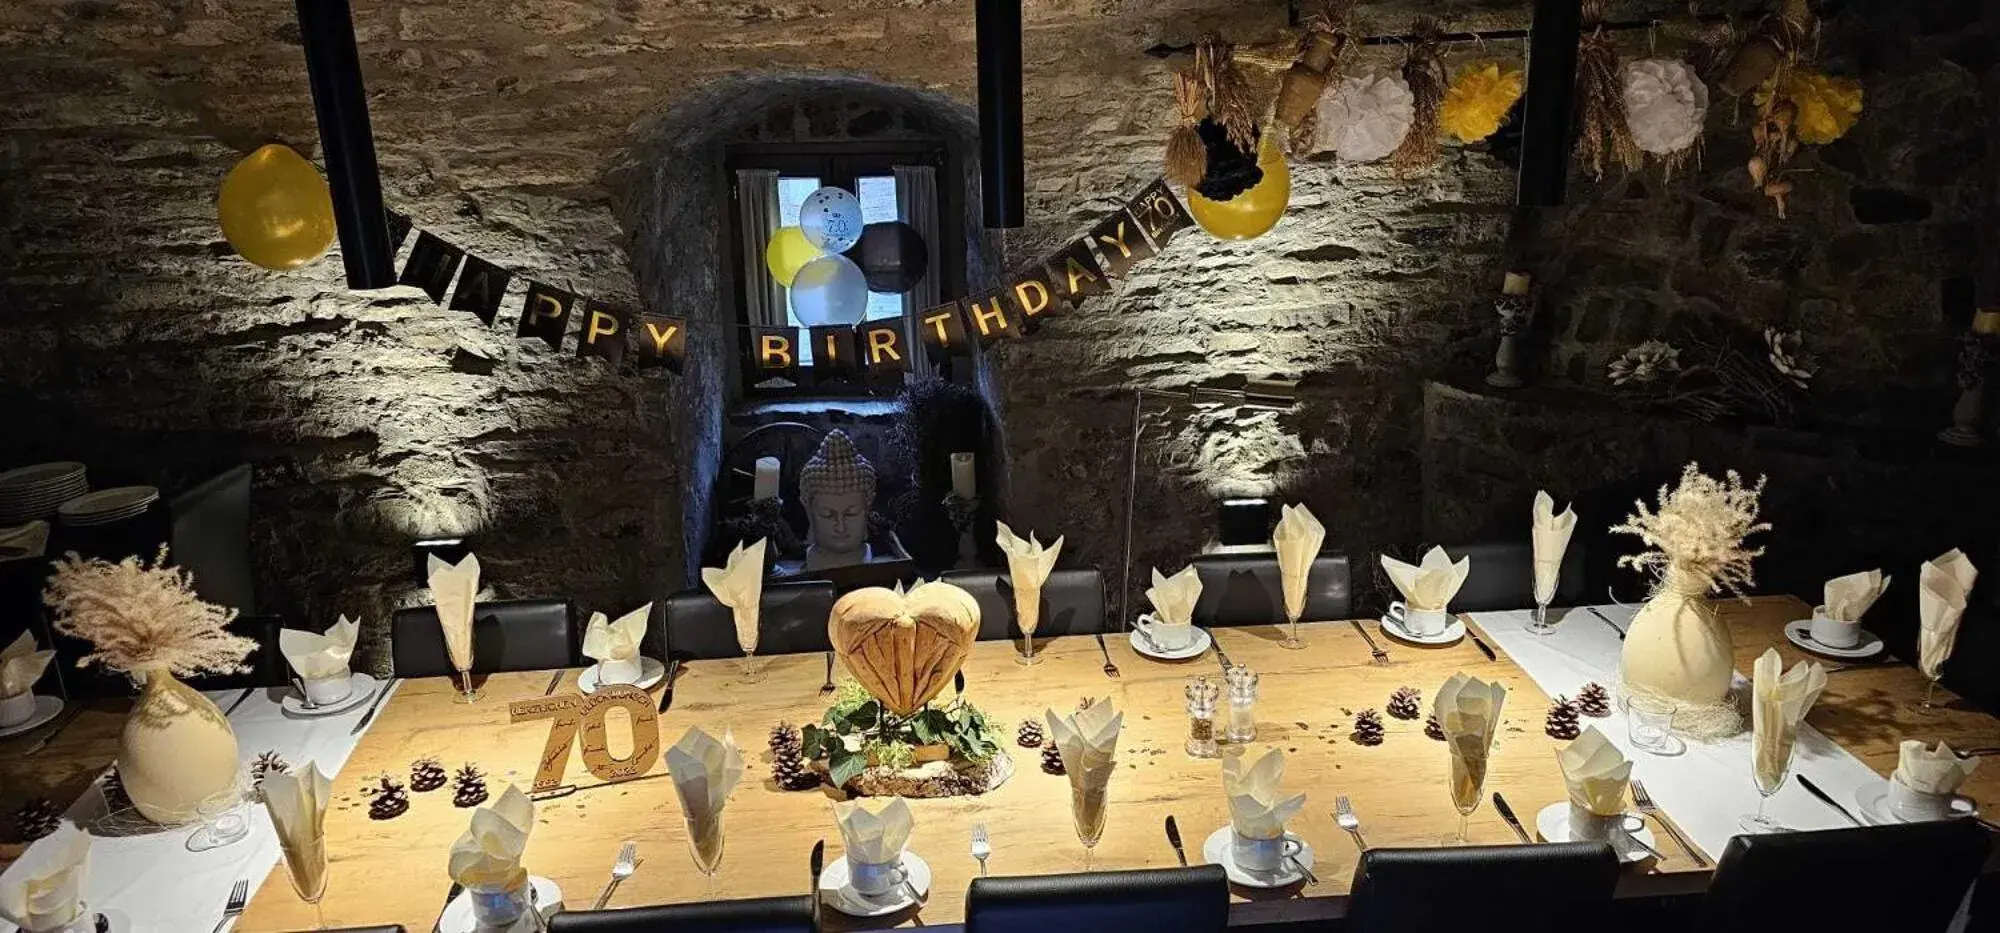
[966,865,1230,933]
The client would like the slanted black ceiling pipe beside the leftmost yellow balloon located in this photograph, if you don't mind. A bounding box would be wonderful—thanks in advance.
[298,0,396,288]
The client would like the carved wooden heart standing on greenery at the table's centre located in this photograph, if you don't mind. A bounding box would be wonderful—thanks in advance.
[826,583,980,717]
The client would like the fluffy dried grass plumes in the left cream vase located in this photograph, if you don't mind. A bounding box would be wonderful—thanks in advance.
[42,547,256,677]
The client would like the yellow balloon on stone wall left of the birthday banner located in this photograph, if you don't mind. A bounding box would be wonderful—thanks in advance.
[216,142,334,270]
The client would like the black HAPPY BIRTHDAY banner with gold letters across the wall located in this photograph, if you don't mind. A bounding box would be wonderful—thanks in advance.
[374,178,1194,382]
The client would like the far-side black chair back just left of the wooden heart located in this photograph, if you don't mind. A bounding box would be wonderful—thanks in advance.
[662,581,834,661]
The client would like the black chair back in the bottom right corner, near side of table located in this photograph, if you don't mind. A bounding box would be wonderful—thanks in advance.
[1694,819,1992,933]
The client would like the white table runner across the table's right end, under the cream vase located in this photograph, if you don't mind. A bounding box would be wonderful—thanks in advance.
[1472,607,1882,859]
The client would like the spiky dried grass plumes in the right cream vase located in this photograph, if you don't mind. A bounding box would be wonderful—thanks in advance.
[1612,462,1770,595]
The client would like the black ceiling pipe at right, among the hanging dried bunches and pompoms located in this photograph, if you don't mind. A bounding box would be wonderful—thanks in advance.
[1514,0,1584,208]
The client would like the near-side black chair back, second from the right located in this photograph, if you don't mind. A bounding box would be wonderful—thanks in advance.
[1344,843,1618,933]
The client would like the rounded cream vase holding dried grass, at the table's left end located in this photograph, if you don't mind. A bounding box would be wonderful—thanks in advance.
[118,667,236,825]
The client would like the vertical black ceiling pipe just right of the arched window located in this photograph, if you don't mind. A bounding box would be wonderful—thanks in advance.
[976,0,1028,228]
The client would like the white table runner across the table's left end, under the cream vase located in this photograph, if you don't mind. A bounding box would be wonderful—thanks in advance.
[0,685,394,933]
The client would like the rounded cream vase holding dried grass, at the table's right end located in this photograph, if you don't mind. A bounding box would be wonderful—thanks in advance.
[1620,567,1736,707]
